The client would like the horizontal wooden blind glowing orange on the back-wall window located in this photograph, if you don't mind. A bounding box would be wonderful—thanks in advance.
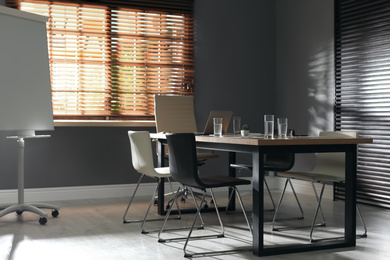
[6,0,194,120]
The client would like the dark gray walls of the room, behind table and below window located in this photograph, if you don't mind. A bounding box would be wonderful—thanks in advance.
[0,0,333,189]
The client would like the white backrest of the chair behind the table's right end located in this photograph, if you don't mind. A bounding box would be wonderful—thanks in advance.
[313,131,359,178]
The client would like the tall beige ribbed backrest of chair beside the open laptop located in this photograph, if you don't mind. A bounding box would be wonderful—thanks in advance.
[154,95,198,133]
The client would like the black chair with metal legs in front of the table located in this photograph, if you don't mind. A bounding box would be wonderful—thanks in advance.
[158,133,252,257]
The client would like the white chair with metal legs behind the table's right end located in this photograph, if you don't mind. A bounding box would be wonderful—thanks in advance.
[272,131,367,242]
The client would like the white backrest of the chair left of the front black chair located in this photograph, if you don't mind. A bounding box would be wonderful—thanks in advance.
[128,131,158,177]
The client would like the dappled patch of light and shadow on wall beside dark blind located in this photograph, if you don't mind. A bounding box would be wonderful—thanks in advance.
[308,43,335,135]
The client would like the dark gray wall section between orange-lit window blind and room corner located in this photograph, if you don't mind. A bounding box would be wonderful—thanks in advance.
[195,0,276,132]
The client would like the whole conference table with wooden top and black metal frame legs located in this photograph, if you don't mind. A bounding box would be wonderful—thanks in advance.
[150,133,373,256]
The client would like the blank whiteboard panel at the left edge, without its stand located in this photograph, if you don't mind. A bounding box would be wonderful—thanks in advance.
[0,6,54,131]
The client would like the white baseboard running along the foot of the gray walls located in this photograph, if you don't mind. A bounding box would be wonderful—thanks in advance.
[0,176,333,204]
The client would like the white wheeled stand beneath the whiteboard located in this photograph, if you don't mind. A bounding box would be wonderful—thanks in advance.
[0,135,59,225]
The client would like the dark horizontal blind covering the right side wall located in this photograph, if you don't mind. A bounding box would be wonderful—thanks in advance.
[335,0,390,207]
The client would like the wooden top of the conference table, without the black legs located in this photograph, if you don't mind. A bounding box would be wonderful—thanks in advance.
[150,133,373,146]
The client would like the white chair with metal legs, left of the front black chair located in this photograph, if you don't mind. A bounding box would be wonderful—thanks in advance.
[123,131,181,234]
